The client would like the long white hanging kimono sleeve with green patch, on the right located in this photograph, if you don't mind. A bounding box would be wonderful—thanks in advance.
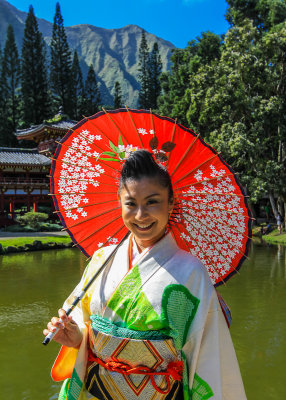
[183,290,246,400]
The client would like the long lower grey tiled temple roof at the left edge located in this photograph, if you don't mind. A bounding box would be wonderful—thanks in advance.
[0,147,51,166]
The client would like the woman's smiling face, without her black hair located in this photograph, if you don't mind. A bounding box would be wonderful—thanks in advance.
[120,178,173,249]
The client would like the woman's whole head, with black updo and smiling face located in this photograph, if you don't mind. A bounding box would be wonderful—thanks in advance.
[119,150,174,252]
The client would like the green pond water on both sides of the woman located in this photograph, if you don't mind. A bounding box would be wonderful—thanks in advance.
[0,245,286,400]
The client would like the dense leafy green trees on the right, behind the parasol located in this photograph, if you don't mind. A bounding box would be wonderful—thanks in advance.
[158,0,286,217]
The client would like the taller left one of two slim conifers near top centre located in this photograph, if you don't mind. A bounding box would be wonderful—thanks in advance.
[138,30,150,109]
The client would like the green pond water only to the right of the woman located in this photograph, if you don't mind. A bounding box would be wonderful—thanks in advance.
[220,245,286,400]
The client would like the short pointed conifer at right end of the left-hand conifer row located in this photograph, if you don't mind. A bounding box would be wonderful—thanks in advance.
[84,64,101,115]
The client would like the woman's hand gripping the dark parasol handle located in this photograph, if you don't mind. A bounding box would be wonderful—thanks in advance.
[43,308,83,347]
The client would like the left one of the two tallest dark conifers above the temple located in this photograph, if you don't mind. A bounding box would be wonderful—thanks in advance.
[21,6,50,126]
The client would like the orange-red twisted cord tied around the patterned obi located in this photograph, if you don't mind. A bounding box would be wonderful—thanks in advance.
[88,348,184,394]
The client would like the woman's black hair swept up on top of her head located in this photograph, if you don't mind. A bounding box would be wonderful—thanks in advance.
[118,150,174,202]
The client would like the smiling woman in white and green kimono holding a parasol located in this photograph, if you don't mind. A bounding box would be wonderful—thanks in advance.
[44,150,246,400]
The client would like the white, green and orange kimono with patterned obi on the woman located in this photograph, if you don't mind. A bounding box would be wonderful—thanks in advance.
[52,233,246,400]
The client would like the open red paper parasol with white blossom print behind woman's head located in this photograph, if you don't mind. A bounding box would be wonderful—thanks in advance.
[51,108,251,286]
